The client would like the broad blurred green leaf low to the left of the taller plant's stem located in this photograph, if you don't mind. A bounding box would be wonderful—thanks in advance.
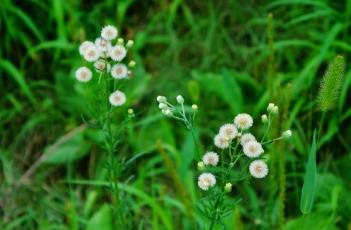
[43,126,91,164]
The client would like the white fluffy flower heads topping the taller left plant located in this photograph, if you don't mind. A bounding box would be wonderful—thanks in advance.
[75,25,135,106]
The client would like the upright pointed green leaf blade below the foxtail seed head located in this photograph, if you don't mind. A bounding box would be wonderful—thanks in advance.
[300,130,317,214]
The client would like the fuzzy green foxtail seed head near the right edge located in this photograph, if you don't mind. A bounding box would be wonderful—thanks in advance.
[317,55,345,112]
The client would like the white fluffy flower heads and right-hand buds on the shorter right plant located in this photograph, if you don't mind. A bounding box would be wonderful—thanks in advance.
[197,103,292,192]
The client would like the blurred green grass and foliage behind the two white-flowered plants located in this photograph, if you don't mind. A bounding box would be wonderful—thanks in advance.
[0,0,351,230]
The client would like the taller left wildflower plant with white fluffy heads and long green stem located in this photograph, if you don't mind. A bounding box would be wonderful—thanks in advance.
[75,25,135,229]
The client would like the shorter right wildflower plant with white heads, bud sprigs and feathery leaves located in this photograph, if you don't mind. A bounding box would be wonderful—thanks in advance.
[157,96,292,229]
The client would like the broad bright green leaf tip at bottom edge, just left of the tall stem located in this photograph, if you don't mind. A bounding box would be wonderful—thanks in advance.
[87,204,113,230]
